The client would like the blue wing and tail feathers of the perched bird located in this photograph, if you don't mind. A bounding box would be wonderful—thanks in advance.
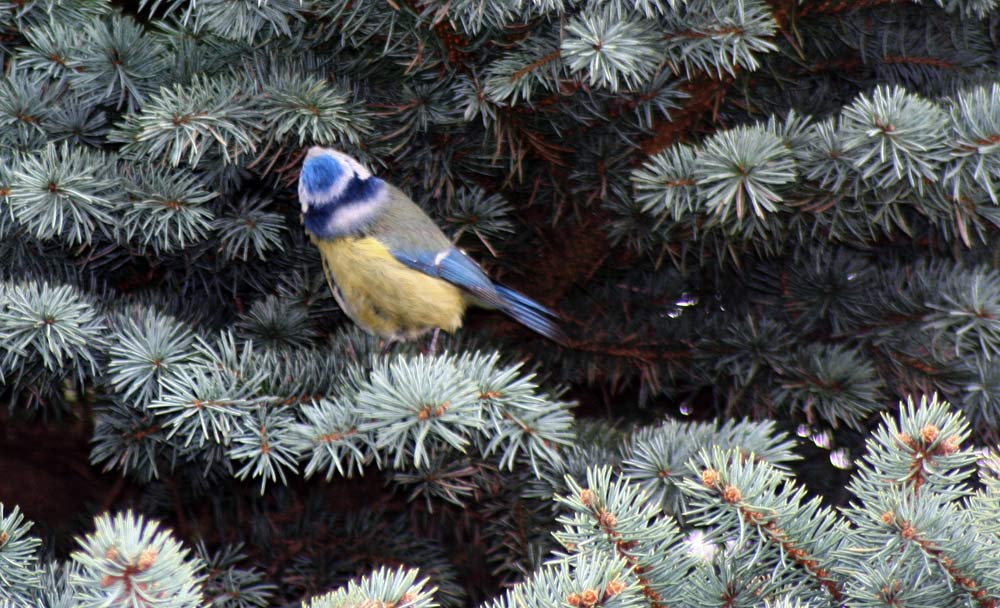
[392,247,566,343]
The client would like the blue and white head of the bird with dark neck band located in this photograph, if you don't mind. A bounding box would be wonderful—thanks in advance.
[299,146,386,238]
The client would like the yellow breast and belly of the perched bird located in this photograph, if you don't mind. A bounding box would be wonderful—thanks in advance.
[313,237,466,339]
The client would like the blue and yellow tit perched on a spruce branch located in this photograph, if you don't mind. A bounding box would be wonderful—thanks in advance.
[299,146,565,343]
